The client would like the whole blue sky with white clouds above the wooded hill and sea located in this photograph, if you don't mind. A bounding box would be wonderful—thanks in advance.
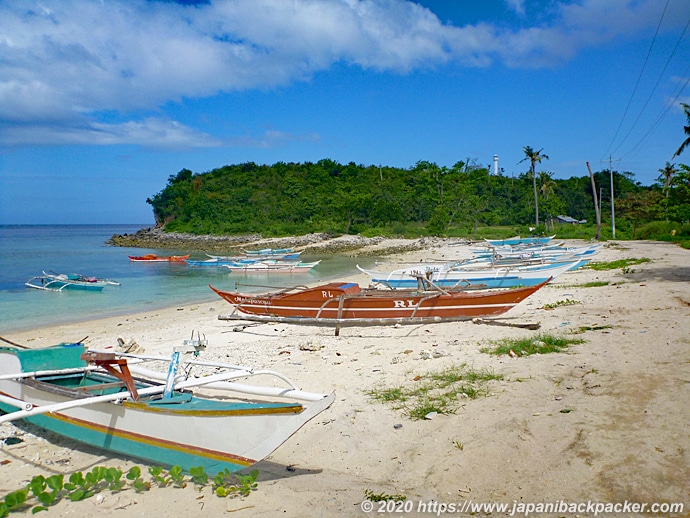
[0,0,690,224]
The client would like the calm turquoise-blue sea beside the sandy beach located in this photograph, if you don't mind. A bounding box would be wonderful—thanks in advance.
[0,225,374,340]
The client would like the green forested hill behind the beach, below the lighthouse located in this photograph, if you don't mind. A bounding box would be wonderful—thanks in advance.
[147,159,690,241]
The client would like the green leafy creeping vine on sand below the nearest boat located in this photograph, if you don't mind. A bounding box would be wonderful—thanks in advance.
[0,466,259,518]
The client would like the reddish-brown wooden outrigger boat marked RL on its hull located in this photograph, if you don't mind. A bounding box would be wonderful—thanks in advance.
[209,279,550,325]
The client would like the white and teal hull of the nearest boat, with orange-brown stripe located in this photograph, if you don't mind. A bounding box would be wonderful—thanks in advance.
[0,348,334,475]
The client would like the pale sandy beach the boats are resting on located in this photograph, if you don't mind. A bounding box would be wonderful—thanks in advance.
[0,241,690,517]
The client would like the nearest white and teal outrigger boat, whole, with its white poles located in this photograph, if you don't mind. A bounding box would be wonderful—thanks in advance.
[0,341,335,476]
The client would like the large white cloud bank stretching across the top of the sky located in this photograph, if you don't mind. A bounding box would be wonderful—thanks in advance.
[0,0,687,147]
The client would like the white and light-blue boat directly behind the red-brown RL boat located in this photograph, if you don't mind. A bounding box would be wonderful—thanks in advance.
[357,259,576,290]
